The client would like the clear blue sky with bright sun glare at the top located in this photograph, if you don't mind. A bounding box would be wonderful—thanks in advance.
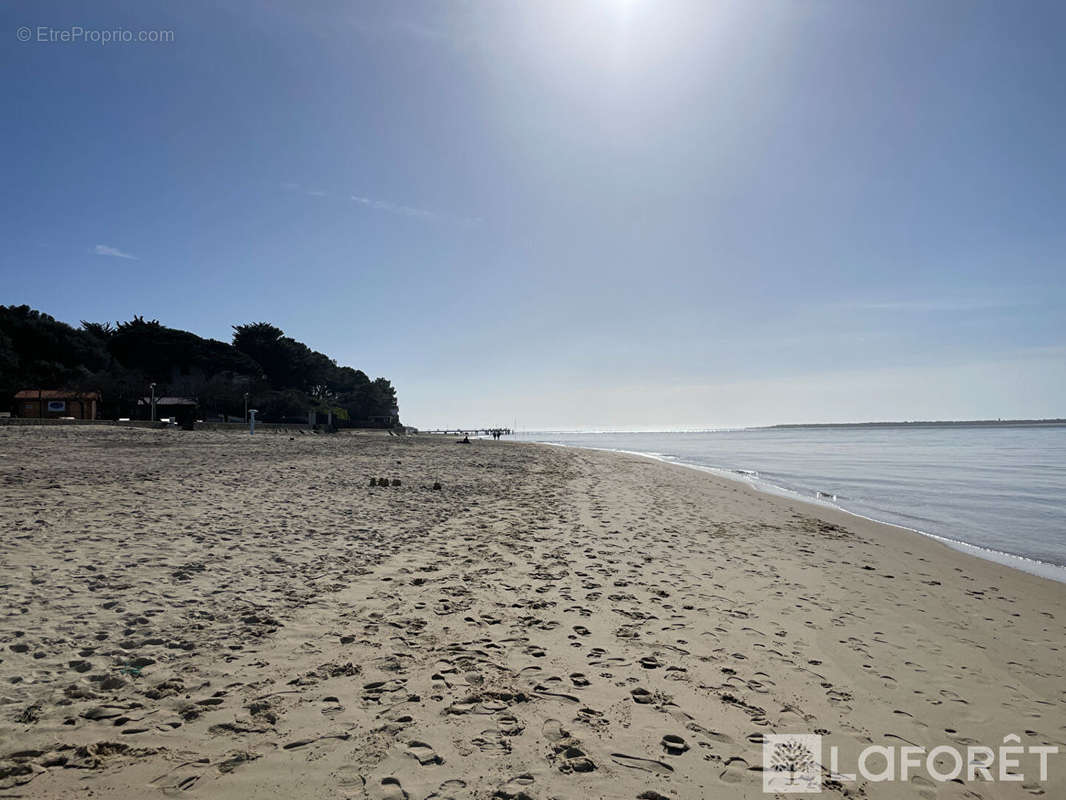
[0,0,1066,430]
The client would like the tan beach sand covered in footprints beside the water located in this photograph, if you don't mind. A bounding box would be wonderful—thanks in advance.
[0,427,1066,800]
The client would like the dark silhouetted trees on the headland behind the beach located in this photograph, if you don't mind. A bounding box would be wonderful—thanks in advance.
[0,305,399,426]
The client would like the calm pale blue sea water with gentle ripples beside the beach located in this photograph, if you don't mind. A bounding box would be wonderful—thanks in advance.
[519,426,1066,581]
